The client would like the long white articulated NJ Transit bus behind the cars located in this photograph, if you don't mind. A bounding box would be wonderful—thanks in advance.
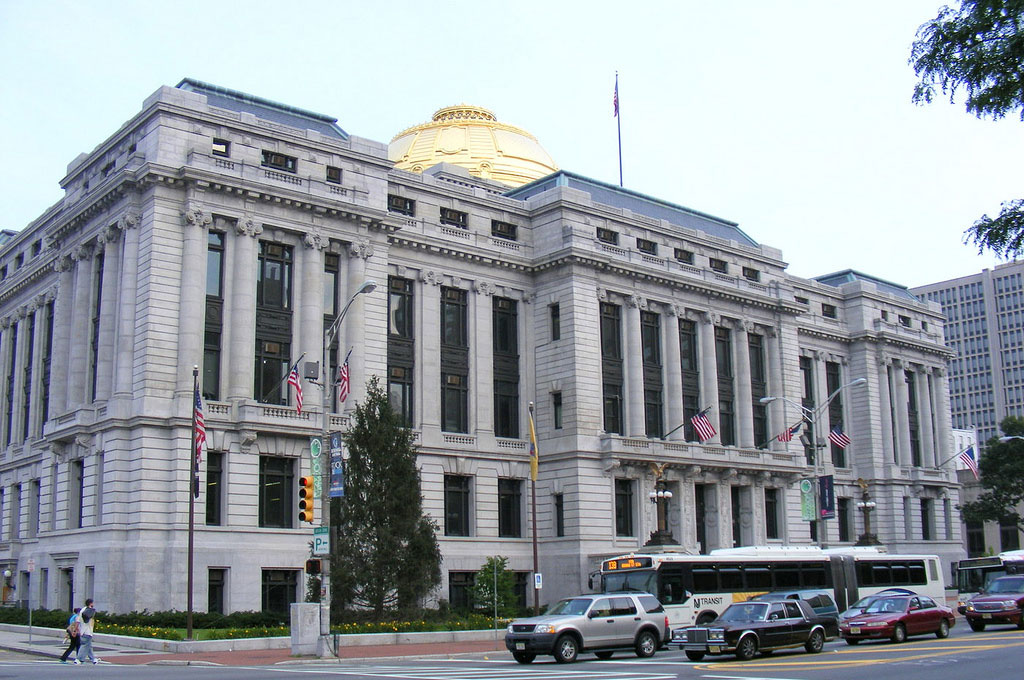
[600,546,945,627]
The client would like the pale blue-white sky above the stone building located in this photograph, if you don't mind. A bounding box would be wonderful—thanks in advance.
[0,0,1024,286]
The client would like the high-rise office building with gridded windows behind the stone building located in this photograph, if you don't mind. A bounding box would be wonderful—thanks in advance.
[912,262,1024,557]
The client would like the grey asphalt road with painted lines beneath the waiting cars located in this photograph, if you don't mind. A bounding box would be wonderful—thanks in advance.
[0,626,1024,680]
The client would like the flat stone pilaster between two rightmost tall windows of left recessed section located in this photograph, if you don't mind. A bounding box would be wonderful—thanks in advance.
[469,281,495,434]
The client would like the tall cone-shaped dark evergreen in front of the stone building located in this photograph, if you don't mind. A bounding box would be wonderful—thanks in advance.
[331,377,441,619]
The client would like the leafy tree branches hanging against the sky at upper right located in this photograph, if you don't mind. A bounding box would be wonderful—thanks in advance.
[910,0,1024,259]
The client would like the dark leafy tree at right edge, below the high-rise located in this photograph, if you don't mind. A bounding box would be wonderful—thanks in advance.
[961,416,1024,530]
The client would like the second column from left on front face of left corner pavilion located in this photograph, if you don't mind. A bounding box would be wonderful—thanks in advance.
[227,217,263,400]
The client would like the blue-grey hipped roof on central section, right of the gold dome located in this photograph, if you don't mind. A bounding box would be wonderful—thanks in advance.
[505,170,758,246]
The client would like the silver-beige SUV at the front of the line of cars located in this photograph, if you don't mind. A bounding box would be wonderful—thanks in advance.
[505,592,669,664]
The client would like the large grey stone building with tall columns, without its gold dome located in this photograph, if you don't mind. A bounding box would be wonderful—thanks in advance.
[0,81,962,611]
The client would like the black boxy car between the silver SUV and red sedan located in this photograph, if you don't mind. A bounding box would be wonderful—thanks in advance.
[672,600,839,662]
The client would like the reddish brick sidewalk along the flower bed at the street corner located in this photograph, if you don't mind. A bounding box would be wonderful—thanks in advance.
[0,626,507,666]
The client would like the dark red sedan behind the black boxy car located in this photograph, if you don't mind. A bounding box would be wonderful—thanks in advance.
[839,595,956,644]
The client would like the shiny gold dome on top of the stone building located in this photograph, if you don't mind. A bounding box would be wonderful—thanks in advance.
[387,104,558,186]
